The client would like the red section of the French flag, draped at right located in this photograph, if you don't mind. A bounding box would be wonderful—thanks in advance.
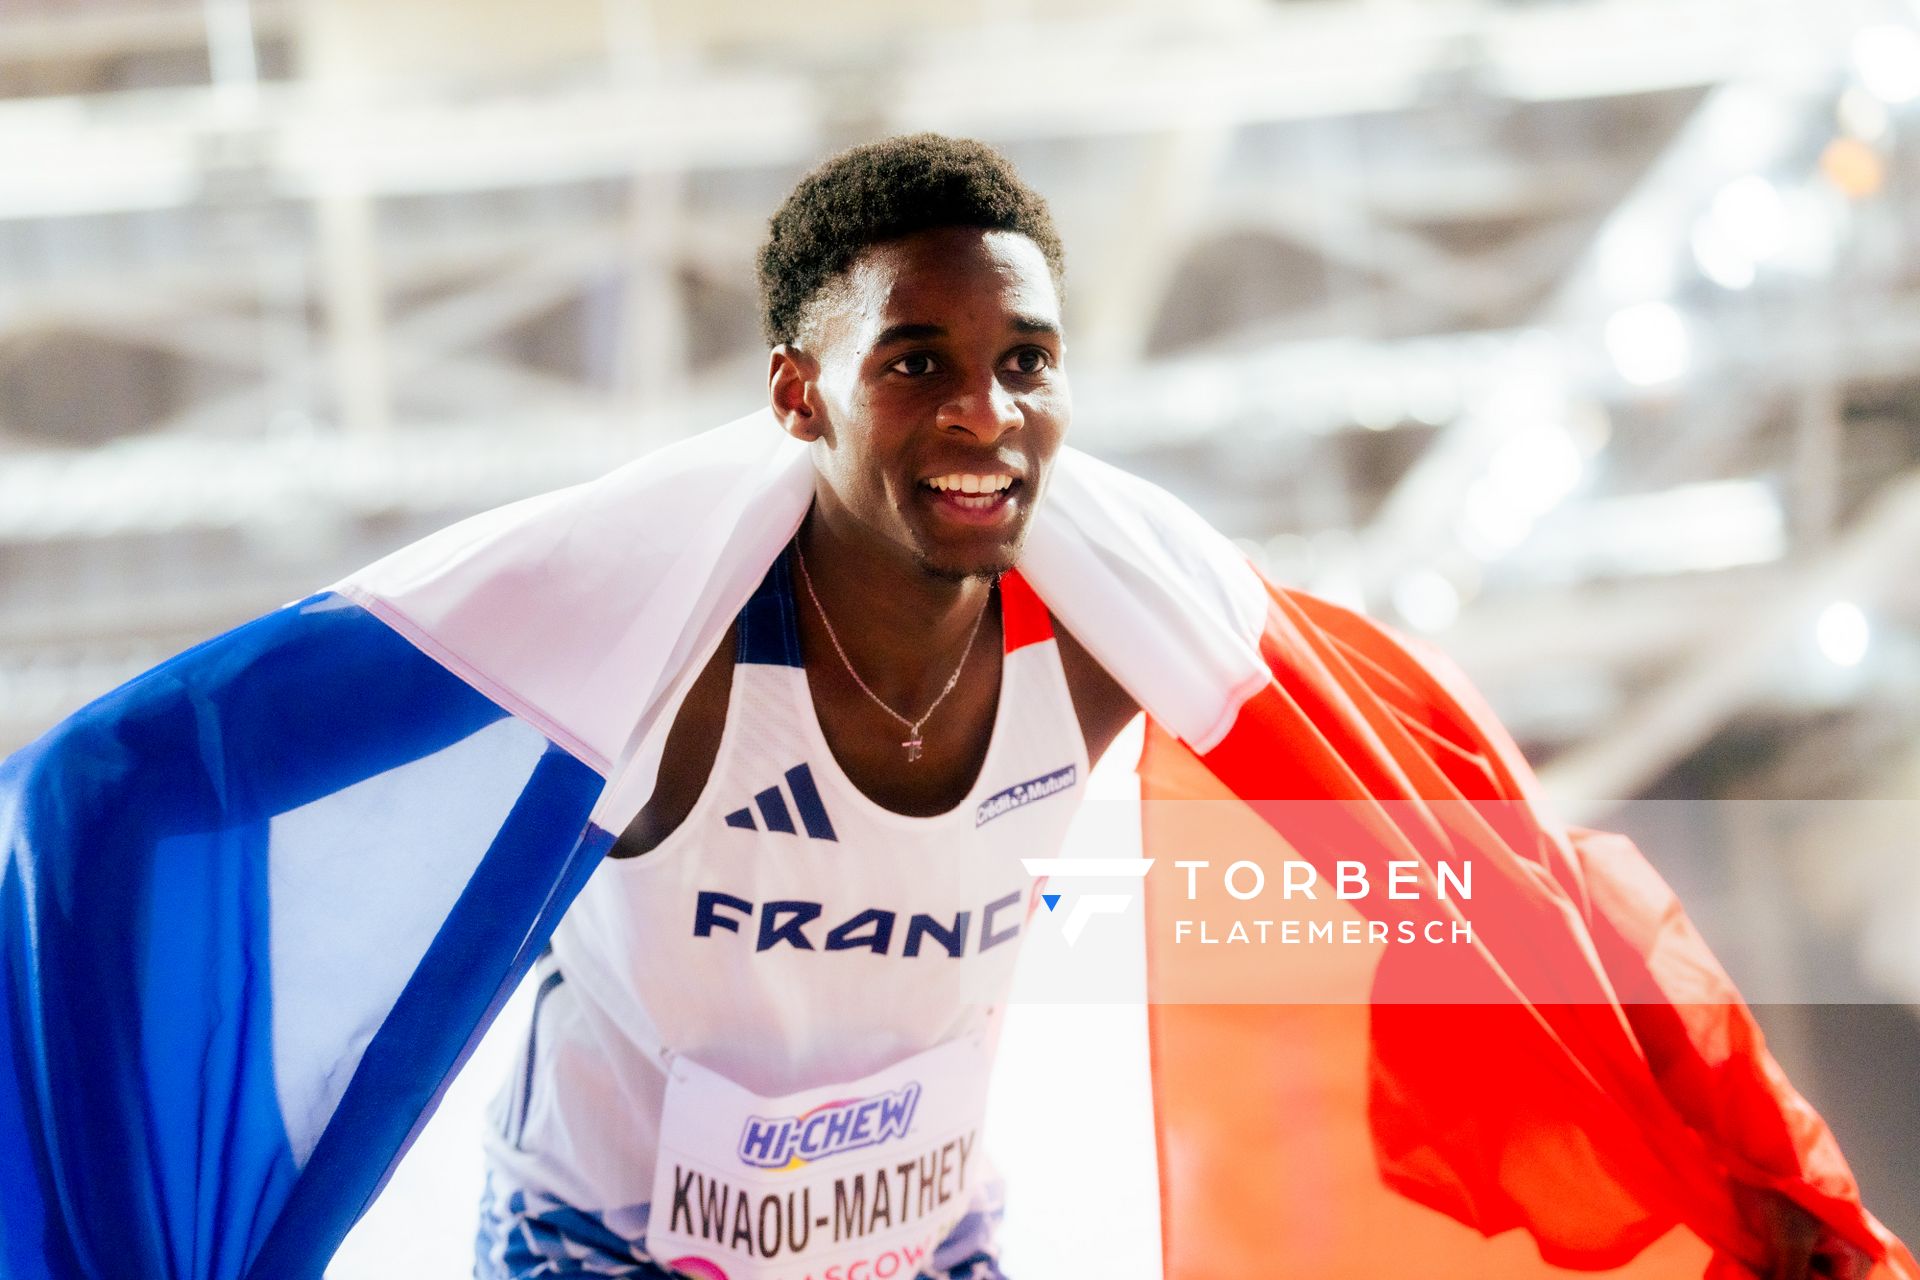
[1140,589,1920,1280]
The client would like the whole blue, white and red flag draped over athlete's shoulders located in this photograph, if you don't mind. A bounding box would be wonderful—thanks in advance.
[0,413,1920,1280]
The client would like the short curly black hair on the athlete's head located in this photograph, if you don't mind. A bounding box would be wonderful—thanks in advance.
[760,132,1066,345]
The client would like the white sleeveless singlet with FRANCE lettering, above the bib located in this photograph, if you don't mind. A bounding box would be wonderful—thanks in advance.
[488,545,1089,1240]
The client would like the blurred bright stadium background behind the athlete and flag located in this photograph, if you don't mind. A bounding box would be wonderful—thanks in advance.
[0,0,1920,1274]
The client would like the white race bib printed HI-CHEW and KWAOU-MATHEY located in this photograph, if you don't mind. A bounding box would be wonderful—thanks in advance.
[647,1038,989,1280]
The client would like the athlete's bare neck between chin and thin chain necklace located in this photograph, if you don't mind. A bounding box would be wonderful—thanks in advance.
[799,503,993,710]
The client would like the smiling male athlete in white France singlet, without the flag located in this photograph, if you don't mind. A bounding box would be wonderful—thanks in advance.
[476,134,1866,1280]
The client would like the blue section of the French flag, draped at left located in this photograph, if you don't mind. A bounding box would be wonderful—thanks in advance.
[0,595,611,1280]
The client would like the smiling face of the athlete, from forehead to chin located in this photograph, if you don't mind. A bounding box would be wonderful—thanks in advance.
[770,226,1071,578]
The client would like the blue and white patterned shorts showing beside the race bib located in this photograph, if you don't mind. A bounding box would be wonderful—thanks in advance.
[474,1169,1006,1280]
